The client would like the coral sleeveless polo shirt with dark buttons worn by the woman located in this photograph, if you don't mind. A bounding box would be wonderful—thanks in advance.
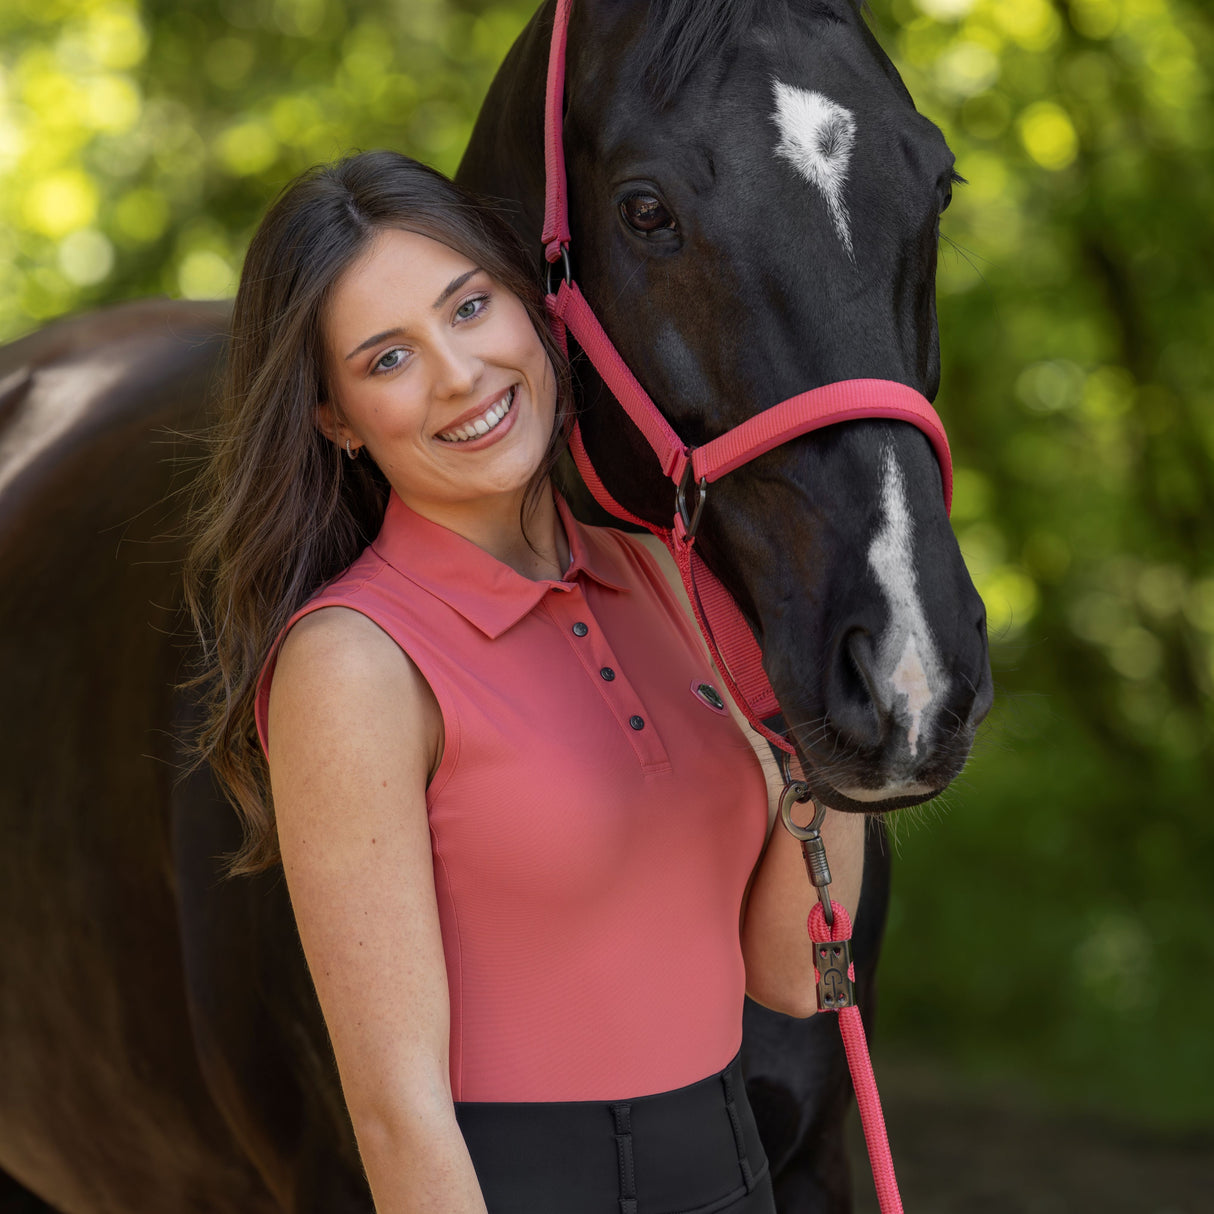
[257,494,767,1101]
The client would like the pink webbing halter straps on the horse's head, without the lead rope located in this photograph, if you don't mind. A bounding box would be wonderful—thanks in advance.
[541,0,953,754]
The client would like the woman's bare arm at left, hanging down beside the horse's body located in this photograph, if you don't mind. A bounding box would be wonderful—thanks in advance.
[270,607,486,1214]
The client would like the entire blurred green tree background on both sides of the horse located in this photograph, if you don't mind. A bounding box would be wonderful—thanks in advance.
[0,0,1214,1125]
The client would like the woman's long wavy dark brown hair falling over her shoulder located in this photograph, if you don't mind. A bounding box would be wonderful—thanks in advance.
[186,152,572,873]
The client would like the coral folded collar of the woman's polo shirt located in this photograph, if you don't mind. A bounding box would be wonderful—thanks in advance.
[371,490,629,640]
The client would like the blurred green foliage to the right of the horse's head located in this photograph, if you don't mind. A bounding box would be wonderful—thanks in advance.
[873,0,1214,1124]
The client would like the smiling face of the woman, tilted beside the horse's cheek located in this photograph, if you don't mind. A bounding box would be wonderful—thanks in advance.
[318,228,556,522]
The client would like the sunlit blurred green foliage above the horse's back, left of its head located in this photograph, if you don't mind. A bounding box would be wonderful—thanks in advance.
[0,0,534,340]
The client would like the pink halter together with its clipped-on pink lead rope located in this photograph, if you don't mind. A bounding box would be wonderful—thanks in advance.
[541,0,912,1214]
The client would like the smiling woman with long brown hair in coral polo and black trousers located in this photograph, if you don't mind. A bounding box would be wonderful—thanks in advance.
[192,153,861,1214]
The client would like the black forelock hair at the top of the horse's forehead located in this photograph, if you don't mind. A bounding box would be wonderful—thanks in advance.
[641,0,840,106]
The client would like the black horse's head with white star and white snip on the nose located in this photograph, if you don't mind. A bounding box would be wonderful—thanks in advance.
[458,0,992,810]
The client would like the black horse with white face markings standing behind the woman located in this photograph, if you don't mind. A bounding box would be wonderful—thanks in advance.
[0,0,991,1214]
